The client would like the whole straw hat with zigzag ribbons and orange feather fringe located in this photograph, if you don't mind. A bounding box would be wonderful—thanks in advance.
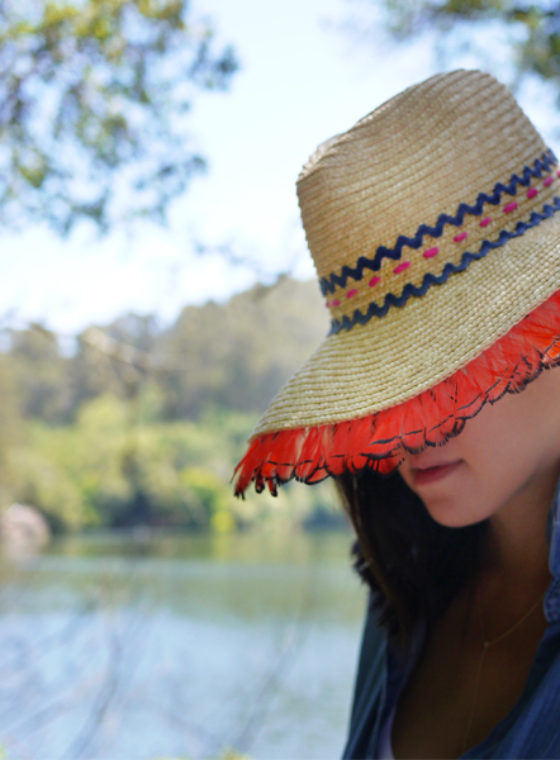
[236,71,560,494]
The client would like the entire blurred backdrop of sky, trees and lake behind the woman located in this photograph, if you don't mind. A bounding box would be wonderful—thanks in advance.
[0,0,560,760]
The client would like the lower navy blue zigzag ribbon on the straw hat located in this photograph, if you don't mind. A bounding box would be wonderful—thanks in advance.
[329,196,560,335]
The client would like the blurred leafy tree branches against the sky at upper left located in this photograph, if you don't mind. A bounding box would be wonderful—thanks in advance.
[0,0,237,235]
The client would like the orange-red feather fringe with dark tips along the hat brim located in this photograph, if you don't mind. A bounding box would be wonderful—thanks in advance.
[235,291,560,496]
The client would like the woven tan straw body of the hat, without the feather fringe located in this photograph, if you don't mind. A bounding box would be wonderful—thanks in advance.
[254,71,560,435]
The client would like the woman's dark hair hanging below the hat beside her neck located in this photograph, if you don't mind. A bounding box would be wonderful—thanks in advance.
[337,470,488,646]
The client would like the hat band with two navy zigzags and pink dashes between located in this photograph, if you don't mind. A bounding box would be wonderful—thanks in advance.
[320,150,560,334]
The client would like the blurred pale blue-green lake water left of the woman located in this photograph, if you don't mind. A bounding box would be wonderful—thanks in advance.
[0,532,365,760]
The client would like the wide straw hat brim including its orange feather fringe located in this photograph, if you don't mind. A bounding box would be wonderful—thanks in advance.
[235,215,560,495]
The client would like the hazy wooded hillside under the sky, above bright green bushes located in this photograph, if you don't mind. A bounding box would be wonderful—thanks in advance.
[4,277,328,423]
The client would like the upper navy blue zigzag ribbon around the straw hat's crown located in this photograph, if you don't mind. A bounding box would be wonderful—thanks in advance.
[319,150,556,296]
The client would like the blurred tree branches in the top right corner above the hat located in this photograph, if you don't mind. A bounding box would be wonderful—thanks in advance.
[368,0,560,95]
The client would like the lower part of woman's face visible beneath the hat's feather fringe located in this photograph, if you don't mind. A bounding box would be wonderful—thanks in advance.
[400,368,560,527]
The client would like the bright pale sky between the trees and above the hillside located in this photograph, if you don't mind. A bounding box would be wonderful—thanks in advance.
[0,0,556,336]
